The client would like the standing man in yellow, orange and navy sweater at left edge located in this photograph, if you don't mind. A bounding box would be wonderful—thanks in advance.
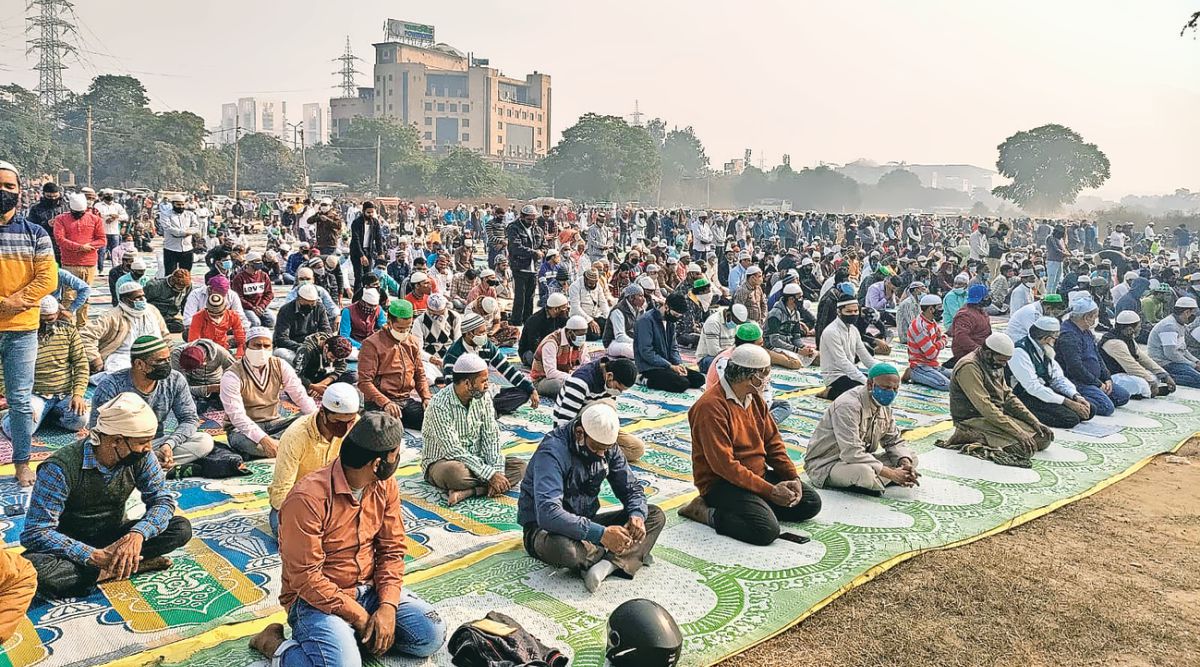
[0,161,59,486]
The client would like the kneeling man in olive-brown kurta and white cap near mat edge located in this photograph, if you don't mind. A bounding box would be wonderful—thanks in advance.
[938,334,1054,468]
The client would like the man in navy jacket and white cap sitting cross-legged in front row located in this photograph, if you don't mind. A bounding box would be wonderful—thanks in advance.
[517,402,666,593]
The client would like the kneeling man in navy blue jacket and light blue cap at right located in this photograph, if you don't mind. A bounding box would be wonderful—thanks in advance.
[1055,296,1129,416]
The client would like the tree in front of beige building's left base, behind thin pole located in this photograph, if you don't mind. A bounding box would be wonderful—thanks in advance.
[331,118,432,194]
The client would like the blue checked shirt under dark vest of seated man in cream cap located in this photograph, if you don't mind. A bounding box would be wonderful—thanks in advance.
[20,440,175,564]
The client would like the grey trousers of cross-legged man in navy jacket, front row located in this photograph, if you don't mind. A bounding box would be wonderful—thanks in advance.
[524,505,667,577]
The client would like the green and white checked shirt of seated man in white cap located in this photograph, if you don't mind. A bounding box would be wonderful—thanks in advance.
[421,386,504,481]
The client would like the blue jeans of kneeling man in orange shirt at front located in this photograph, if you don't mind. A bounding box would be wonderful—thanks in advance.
[272,585,446,667]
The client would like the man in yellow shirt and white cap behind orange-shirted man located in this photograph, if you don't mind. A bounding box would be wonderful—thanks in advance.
[266,383,362,535]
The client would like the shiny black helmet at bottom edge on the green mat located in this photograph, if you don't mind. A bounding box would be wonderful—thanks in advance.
[605,599,683,667]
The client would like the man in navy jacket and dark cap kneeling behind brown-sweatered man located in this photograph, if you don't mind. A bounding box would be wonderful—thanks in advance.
[634,292,704,393]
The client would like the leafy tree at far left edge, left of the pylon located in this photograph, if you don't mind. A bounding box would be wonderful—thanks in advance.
[0,84,62,174]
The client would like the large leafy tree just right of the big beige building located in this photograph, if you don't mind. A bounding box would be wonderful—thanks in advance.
[536,114,662,202]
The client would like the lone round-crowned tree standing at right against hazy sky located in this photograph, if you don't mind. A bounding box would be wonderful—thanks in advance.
[991,125,1110,214]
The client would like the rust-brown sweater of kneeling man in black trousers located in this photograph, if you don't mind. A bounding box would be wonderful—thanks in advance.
[688,383,799,498]
